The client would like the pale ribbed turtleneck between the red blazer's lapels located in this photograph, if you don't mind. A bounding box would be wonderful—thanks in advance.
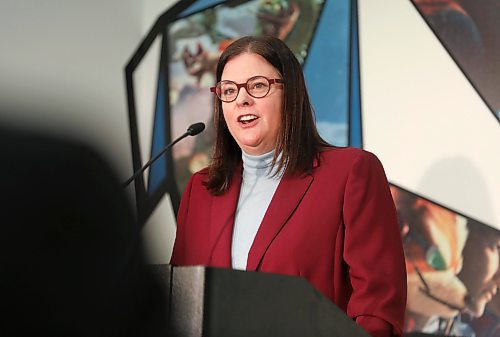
[231,151,282,270]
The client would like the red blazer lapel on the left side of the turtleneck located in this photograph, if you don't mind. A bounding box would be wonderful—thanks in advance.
[209,165,242,268]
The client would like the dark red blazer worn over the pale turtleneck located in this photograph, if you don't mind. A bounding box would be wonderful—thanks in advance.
[171,147,406,337]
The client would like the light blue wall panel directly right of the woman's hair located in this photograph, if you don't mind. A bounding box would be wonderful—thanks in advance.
[304,0,350,146]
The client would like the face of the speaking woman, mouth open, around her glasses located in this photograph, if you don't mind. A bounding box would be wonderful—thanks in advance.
[221,53,283,155]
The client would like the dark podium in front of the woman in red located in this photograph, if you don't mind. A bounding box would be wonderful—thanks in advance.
[154,265,369,337]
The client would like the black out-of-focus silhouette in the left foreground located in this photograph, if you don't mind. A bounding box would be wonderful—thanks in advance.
[0,123,167,337]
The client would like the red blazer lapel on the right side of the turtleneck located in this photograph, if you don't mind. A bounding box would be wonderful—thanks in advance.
[247,175,313,270]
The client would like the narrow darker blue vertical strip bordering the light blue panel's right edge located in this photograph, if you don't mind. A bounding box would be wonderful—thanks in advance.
[349,0,362,147]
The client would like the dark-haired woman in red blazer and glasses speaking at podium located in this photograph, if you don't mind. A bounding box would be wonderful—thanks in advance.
[171,37,406,336]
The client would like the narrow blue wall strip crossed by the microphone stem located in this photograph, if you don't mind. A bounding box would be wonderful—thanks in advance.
[148,69,167,194]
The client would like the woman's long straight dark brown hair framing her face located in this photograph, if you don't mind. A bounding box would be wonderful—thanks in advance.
[206,36,328,195]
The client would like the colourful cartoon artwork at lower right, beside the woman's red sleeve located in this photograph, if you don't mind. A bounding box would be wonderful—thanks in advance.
[391,186,500,337]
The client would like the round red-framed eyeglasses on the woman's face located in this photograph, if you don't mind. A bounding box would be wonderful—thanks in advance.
[210,76,285,103]
